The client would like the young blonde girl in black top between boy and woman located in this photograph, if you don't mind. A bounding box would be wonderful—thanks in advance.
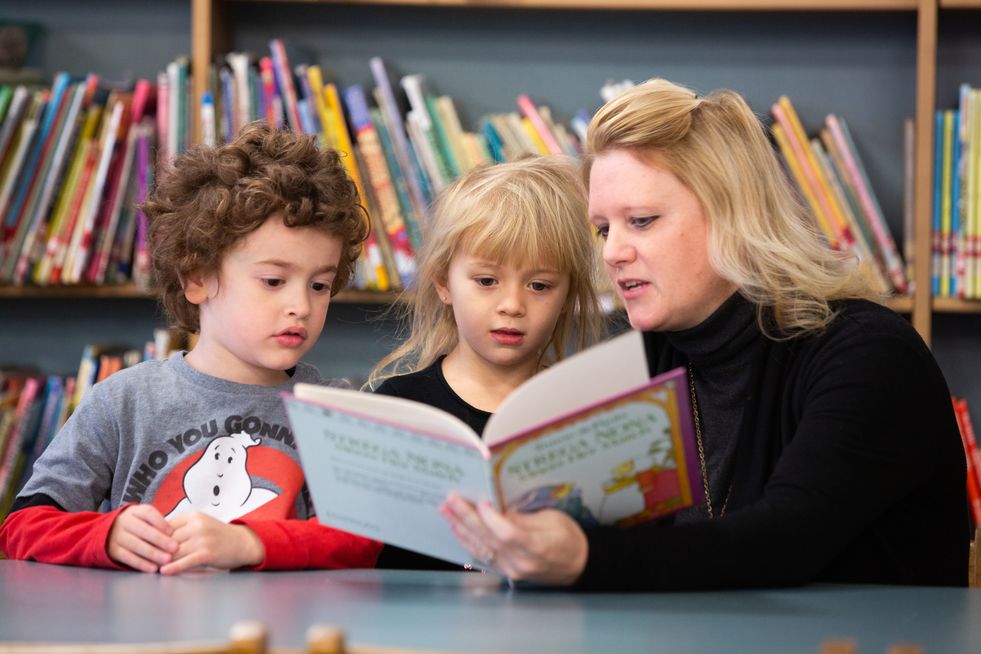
[368,156,600,568]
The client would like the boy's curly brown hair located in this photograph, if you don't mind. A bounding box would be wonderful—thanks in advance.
[142,122,368,333]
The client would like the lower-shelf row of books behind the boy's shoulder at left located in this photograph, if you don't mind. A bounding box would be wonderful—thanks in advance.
[0,329,187,521]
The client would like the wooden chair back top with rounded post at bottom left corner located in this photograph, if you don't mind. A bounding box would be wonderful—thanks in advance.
[0,621,269,654]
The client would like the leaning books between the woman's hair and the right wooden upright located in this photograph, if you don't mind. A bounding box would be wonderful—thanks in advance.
[771,96,912,294]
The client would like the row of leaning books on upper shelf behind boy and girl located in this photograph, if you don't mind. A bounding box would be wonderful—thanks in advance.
[192,39,588,290]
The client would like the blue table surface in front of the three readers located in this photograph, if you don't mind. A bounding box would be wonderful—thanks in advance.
[0,561,981,654]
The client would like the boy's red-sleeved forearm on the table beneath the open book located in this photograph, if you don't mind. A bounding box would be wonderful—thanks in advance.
[232,518,382,570]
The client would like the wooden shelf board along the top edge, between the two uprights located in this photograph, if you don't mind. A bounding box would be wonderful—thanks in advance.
[228,0,919,11]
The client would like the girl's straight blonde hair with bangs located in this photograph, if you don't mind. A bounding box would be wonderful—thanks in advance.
[365,156,600,388]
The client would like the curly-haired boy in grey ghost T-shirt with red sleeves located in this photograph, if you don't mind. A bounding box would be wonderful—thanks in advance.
[0,123,381,575]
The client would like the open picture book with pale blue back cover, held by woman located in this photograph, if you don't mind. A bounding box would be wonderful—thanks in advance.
[283,332,703,567]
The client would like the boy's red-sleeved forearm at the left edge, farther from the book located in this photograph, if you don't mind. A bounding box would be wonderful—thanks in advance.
[0,502,128,570]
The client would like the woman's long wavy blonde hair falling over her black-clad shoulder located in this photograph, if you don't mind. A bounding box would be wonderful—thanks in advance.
[583,79,876,338]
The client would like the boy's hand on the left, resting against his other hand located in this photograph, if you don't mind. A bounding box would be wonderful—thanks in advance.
[106,504,178,572]
